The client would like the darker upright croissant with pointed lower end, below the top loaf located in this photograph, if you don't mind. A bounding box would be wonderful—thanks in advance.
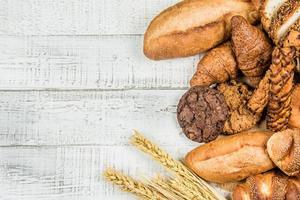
[231,16,272,86]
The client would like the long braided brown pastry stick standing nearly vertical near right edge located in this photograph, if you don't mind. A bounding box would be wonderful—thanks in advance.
[267,47,296,132]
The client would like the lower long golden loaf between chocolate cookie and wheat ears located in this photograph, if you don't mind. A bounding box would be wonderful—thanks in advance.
[185,131,274,183]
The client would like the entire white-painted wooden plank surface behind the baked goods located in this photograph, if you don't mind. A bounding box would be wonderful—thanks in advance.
[0,0,213,200]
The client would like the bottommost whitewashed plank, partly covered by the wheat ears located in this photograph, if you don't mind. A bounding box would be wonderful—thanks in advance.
[0,145,205,200]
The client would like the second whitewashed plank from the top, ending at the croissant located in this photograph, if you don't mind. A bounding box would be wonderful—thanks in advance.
[0,36,199,90]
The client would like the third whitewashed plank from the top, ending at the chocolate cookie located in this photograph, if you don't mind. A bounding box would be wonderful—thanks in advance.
[0,90,199,146]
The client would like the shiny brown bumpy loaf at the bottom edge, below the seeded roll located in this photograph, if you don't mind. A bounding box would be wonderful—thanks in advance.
[232,171,300,200]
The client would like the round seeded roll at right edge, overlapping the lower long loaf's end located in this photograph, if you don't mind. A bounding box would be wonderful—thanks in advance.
[267,129,300,176]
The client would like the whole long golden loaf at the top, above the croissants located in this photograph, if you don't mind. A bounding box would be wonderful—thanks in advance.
[144,0,259,60]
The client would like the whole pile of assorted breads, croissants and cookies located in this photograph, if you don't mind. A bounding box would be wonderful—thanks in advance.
[144,0,300,200]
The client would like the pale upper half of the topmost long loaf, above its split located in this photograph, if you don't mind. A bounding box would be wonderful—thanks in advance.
[146,0,253,39]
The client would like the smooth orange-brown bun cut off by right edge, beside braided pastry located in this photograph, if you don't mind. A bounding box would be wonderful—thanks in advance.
[289,84,300,128]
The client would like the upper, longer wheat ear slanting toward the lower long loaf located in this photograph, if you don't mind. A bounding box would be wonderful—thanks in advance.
[131,131,225,200]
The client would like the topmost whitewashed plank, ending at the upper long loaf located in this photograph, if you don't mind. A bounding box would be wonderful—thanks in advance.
[0,0,179,35]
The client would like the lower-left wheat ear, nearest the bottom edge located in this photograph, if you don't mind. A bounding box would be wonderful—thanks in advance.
[103,168,168,200]
